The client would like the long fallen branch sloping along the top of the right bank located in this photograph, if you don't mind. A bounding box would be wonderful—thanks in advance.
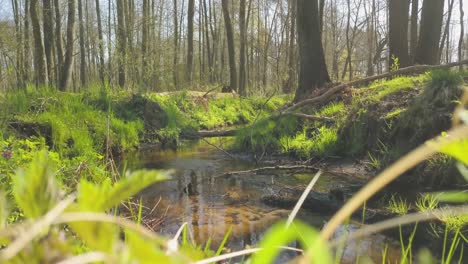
[282,60,468,114]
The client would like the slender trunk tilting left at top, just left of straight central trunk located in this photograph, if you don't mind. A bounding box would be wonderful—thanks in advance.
[221,0,237,91]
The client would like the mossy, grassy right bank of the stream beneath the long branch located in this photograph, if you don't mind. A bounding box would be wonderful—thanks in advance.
[236,70,467,185]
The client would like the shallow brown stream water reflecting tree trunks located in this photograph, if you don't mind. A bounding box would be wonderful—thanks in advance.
[126,140,398,262]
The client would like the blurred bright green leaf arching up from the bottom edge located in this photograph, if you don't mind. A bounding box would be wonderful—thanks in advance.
[252,222,332,264]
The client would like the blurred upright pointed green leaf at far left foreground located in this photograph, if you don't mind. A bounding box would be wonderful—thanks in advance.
[13,151,60,219]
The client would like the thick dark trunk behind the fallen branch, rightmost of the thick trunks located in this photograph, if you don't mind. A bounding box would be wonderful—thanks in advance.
[415,0,444,65]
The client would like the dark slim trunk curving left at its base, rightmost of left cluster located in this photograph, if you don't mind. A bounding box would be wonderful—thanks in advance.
[59,0,75,91]
